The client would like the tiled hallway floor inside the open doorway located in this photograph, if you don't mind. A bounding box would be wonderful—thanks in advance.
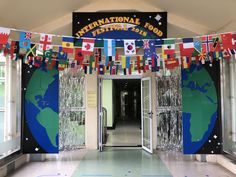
[106,121,142,146]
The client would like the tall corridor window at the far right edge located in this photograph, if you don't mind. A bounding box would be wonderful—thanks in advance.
[221,59,236,157]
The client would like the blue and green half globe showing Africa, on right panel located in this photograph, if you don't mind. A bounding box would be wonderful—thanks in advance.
[182,64,218,154]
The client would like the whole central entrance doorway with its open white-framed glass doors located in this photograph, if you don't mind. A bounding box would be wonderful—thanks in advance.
[98,77,153,153]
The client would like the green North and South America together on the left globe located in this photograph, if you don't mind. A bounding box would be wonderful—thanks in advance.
[25,69,58,147]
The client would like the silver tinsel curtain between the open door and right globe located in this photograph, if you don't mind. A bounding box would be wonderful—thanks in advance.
[156,69,182,151]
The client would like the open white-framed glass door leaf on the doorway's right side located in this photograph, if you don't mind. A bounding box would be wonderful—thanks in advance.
[141,77,153,153]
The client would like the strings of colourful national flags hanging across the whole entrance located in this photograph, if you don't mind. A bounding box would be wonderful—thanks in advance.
[0,27,236,75]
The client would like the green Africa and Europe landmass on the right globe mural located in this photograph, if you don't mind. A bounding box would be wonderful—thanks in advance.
[182,68,218,142]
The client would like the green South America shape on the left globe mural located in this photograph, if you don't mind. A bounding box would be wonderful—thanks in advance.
[37,108,58,147]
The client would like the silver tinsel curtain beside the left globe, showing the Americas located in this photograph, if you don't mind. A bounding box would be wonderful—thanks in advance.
[59,69,85,151]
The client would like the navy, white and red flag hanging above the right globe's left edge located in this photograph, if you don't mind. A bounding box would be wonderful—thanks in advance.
[179,38,194,57]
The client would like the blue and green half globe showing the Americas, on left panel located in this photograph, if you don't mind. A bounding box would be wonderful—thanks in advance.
[24,68,59,153]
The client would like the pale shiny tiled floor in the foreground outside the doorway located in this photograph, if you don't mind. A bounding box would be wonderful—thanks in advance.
[7,148,236,177]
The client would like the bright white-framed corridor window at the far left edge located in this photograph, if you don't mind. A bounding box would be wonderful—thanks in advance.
[0,54,21,159]
